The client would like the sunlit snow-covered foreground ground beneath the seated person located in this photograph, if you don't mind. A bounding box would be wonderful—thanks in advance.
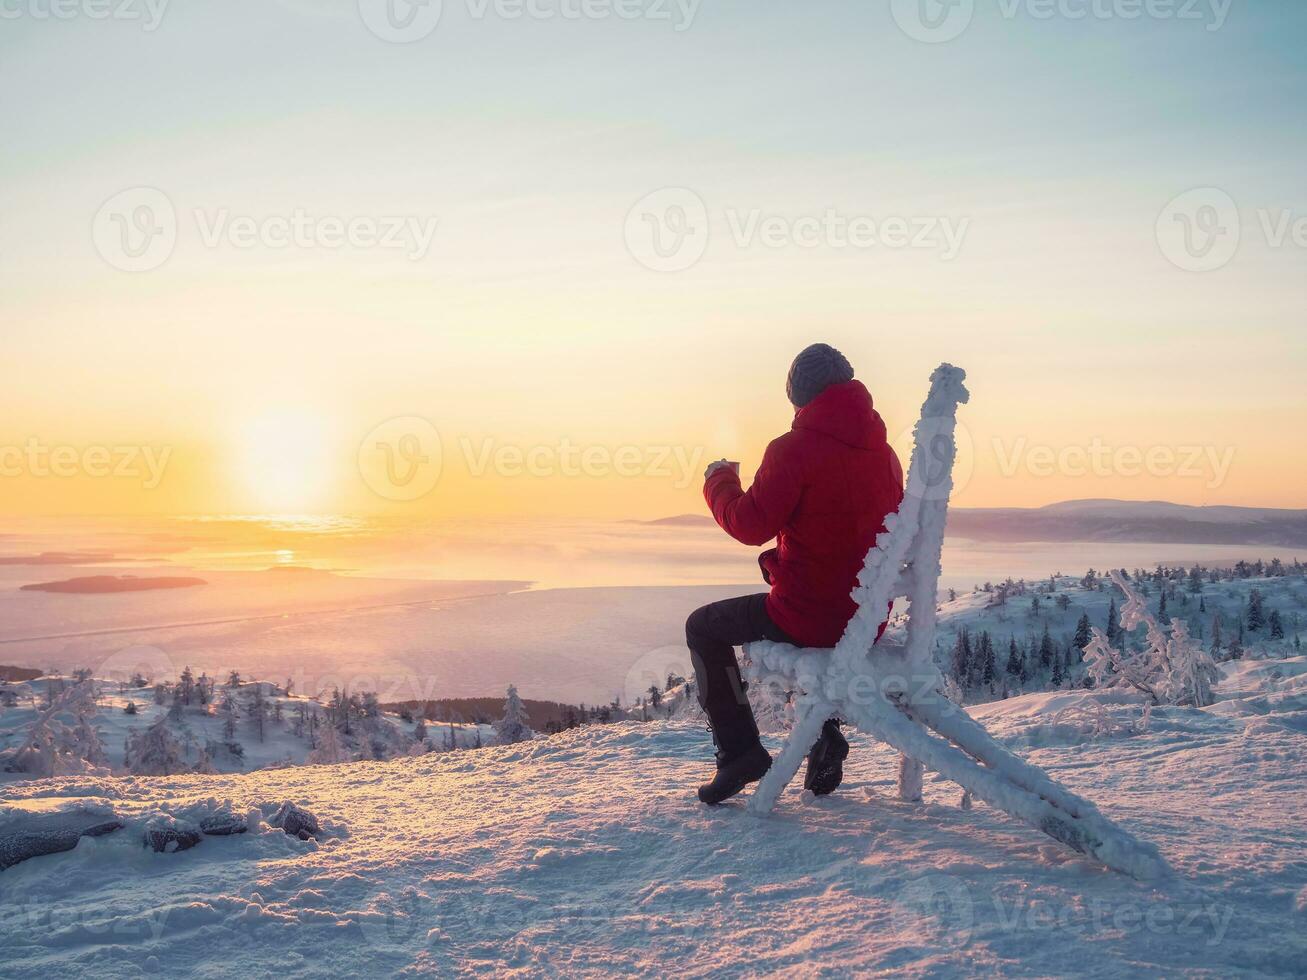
[0,657,1307,979]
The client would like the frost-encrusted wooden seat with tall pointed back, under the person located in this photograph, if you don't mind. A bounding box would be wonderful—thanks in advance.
[745,365,1168,879]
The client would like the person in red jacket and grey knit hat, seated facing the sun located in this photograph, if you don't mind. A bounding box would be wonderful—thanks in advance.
[685,344,903,804]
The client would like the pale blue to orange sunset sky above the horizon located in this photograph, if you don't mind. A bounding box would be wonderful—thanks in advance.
[0,0,1307,517]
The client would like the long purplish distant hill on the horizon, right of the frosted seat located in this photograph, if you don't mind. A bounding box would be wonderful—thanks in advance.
[949,500,1307,547]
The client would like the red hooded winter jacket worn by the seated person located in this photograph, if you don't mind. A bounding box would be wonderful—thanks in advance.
[703,382,903,647]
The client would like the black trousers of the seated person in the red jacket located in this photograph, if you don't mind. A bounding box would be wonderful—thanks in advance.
[685,592,797,754]
